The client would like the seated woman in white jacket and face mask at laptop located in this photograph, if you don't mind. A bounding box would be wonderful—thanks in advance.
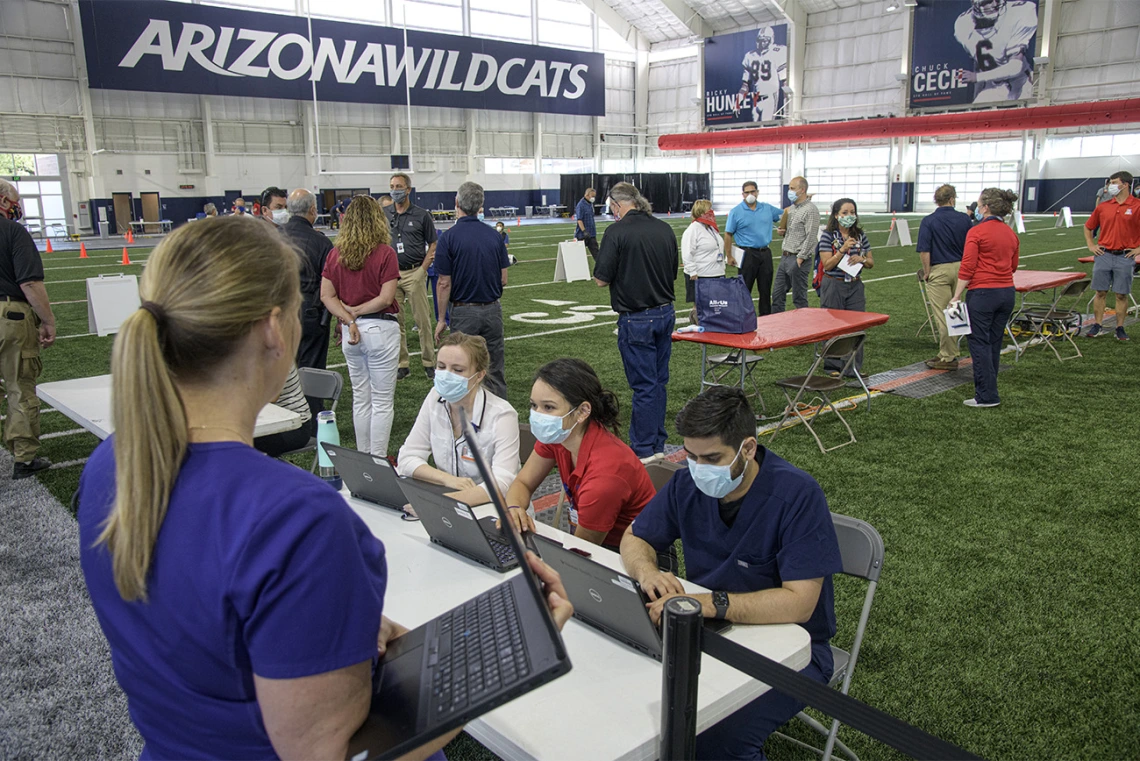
[396,333,519,505]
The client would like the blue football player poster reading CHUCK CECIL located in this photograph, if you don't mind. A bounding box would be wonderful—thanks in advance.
[911,0,1037,108]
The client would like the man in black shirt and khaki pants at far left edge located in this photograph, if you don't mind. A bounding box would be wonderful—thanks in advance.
[0,180,56,478]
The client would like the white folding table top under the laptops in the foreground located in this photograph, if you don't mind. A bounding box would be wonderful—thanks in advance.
[344,492,812,761]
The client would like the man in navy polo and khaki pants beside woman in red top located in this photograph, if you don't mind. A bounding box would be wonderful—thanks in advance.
[918,185,972,370]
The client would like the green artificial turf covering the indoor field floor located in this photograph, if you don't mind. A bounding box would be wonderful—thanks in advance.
[20,215,1140,760]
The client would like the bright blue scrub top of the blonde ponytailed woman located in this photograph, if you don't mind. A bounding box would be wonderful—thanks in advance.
[79,436,388,759]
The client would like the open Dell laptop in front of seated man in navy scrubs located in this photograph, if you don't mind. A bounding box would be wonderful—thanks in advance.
[535,537,732,661]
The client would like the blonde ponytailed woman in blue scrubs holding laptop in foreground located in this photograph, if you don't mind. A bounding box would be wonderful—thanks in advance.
[78,218,571,759]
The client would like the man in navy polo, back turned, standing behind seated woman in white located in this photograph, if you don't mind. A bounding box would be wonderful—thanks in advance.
[435,182,511,399]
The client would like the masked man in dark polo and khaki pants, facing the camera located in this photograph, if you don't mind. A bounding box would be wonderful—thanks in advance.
[385,173,435,378]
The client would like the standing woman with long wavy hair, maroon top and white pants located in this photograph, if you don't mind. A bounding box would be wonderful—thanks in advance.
[320,196,400,457]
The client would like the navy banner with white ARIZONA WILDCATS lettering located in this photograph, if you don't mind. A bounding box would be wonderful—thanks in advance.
[79,0,605,116]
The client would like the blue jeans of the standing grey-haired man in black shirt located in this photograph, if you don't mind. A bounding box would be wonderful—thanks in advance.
[618,303,676,457]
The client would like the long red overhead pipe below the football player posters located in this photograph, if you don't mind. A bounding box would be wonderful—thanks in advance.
[657,98,1140,150]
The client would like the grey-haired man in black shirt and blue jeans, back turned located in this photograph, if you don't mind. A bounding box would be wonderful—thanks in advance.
[594,182,677,461]
